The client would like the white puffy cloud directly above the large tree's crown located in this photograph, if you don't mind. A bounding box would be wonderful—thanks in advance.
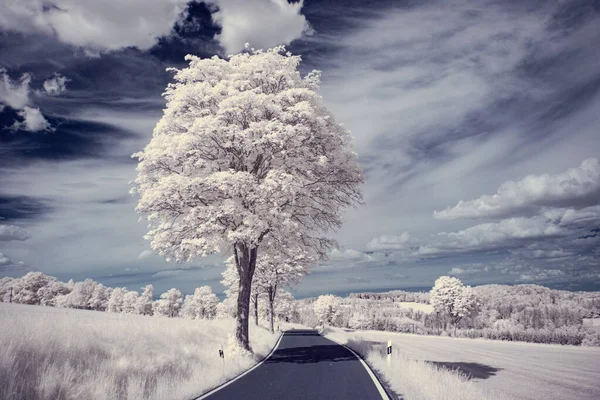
[212,0,312,54]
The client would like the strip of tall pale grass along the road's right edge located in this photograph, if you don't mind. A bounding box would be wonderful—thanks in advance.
[323,328,510,400]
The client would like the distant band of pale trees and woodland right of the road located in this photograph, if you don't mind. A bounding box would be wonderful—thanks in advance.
[296,277,600,346]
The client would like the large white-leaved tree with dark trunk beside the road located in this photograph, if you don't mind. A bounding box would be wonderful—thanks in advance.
[133,47,363,350]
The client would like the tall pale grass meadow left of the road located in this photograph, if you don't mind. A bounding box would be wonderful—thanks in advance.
[0,303,277,400]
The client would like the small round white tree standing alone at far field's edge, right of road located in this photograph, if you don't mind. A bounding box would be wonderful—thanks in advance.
[430,276,477,335]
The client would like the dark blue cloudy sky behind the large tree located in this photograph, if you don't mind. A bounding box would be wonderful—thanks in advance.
[0,0,600,297]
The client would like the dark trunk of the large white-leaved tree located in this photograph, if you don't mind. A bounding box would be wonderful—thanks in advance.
[234,244,258,351]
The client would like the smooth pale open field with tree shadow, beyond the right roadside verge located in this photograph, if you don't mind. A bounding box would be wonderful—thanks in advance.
[334,329,600,400]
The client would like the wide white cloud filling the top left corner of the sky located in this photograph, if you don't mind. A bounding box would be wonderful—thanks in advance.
[0,0,189,52]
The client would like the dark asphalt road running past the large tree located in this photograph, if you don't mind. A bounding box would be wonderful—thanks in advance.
[206,330,382,400]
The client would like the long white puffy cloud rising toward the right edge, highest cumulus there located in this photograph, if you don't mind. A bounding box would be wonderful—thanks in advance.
[433,158,600,219]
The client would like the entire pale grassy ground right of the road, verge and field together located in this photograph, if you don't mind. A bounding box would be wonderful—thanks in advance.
[326,328,600,400]
